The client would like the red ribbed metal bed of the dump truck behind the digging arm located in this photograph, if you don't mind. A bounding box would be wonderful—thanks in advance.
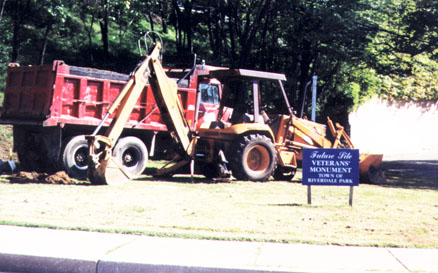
[0,61,196,131]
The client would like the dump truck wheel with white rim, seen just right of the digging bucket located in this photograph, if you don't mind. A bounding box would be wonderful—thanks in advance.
[113,136,148,176]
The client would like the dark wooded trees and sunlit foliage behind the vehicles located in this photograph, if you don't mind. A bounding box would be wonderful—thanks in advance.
[0,0,438,120]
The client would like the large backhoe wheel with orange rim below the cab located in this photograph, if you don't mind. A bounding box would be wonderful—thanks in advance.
[230,134,277,181]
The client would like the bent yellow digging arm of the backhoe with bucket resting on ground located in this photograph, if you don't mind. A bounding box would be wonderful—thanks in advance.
[87,43,191,184]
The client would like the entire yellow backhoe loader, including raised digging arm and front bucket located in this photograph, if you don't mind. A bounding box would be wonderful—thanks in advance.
[87,33,382,184]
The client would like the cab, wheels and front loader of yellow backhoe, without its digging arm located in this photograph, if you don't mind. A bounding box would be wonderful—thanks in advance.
[158,69,383,182]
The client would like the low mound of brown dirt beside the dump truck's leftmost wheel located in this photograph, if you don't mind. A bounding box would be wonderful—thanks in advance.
[10,171,73,184]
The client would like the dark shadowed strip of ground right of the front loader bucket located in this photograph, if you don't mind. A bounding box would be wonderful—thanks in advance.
[381,160,438,190]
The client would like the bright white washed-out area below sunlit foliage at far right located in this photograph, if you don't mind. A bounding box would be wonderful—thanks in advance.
[349,98,438,159]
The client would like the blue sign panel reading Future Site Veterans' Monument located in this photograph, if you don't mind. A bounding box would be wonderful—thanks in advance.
[302,148,359,186]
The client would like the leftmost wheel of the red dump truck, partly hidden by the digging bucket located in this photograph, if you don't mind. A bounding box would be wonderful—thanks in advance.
[61,135,88,179]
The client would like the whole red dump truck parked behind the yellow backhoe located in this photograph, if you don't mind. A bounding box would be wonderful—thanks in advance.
[0,61,227,178]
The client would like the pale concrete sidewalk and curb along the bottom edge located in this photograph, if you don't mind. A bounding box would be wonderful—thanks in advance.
[0,226,438,273]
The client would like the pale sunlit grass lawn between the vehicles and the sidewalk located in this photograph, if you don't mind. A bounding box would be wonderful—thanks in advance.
[0,171,438,248]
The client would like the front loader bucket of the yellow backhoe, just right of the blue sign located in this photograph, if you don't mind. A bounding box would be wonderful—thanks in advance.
[359,153,386,184]
